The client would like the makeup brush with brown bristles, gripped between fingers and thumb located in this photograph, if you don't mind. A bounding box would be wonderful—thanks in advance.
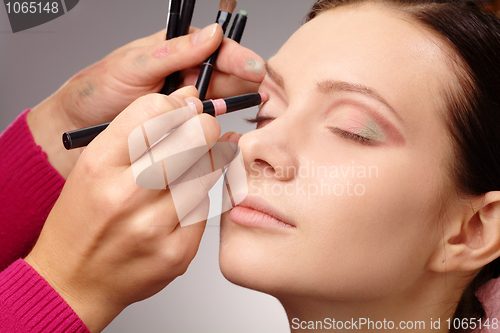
[196,0,237,100]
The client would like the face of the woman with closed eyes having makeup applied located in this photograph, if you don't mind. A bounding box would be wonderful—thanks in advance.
[220,5,456,300]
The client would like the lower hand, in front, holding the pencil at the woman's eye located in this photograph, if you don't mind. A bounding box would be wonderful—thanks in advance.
[25,87,239,332]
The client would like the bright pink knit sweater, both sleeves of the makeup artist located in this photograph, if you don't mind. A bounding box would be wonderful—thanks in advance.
[0,110,89,333]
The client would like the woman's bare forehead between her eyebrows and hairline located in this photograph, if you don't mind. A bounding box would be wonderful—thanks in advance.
[269,4,455,124]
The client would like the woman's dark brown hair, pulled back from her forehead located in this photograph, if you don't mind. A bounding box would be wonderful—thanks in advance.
[306,0,500,332]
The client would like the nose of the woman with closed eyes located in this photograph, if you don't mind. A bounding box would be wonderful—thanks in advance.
[238,120,297,181]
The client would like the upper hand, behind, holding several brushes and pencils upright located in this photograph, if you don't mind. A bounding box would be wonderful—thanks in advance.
[28,24,265,178]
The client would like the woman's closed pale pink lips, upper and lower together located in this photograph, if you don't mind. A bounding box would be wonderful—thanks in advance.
[229,197,296,229]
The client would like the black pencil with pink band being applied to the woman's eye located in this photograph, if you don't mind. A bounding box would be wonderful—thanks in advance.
[62,92,269,150]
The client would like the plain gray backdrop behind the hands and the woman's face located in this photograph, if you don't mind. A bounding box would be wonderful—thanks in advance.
[0,0,314,333]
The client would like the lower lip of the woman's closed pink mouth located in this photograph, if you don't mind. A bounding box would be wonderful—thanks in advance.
[228,206,294,229]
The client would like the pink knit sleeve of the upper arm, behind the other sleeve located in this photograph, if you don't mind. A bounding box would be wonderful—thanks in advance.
[0,110,64,271]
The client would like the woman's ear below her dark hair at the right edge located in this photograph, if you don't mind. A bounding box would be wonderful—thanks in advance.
[427,191,500,273]
